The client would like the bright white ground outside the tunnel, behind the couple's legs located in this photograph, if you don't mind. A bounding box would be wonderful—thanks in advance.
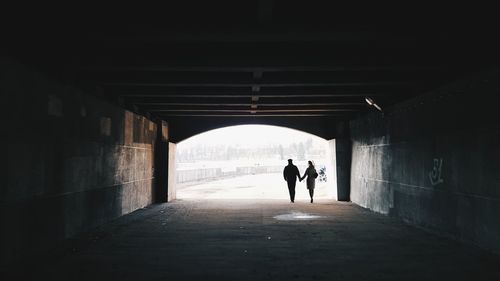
[177,173,336,199]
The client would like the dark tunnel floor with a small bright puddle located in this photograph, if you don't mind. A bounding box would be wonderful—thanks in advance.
[3,200,500,281]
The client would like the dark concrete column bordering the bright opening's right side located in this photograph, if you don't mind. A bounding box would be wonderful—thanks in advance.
[335,122,352,201]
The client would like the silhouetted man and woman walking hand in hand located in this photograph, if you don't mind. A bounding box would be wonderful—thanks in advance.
[283,159,318,203]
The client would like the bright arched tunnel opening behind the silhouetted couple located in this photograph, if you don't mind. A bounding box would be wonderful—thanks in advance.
[176,125,337,202]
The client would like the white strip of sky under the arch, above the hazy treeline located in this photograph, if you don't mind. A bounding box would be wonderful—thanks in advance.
[179,125,326,148]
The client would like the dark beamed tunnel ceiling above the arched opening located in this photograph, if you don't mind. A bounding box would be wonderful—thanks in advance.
[4,3,497,141]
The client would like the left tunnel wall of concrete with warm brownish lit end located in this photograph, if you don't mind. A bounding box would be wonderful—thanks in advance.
[0,58,156,264]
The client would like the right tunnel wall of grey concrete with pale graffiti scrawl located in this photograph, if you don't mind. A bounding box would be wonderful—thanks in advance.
[350,69,500,252]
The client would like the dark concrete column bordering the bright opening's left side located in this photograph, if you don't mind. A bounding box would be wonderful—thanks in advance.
[153,121,169,203]
